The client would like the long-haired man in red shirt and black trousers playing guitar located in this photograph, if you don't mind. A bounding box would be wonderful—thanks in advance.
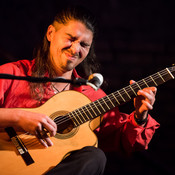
[0,5,159,175]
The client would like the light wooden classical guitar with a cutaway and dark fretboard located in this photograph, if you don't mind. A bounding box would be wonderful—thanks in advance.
[0,66,175,175]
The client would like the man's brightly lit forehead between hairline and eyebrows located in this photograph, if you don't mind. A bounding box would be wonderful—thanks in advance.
[54,20,93,38]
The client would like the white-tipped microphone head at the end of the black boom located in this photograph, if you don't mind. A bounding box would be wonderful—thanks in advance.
[86,73,103,91]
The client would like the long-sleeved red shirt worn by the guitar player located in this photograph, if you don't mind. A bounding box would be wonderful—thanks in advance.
[0,60,159,153]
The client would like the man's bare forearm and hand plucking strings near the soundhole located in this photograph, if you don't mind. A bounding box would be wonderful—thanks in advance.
[0,108,57,147]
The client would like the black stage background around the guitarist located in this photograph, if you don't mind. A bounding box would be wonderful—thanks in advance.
[0,0,175,175]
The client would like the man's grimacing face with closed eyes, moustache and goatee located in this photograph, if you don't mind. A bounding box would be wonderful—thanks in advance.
[47,20,93,74]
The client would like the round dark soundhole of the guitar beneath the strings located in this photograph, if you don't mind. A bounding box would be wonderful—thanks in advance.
[54,116,74,134]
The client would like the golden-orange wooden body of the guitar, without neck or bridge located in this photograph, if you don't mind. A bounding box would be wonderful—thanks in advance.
[0,91,100,175]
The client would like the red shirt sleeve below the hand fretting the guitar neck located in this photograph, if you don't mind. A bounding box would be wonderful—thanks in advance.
[96,108,159,153]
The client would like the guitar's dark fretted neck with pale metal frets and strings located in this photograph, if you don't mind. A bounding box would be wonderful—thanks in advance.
[67,66,175,126]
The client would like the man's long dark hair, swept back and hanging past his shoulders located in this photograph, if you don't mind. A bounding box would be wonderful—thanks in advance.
[31,6,100,98]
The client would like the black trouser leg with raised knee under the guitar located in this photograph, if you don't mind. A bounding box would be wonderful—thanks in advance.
[46,146,106,175]
